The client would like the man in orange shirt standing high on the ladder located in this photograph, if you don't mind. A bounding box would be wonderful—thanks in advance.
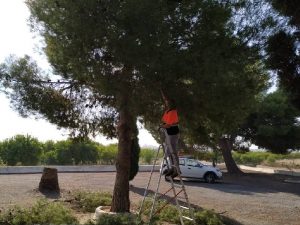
[162,98,180,177]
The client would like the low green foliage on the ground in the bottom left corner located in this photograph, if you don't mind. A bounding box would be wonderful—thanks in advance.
[0,200,79,225]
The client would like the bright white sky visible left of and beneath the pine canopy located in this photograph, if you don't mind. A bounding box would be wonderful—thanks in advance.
[0,0,158,146]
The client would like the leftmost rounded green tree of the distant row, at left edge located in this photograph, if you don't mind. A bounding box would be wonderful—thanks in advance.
[0,135,42,166]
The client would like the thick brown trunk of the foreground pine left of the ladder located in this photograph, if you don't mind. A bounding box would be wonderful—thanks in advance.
[111,92,135,212]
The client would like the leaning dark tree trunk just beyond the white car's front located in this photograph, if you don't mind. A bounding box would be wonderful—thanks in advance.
[219,138,243,174]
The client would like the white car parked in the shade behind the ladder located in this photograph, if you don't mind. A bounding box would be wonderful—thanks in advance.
[162,157,222,183]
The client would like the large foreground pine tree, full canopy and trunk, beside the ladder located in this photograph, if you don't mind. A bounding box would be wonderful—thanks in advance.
[1,0,266,212]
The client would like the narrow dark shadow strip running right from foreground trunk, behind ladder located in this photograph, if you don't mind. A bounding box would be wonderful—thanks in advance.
[130,185,243,225]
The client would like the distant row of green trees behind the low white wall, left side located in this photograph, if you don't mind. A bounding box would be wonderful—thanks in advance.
[0,135,155,166]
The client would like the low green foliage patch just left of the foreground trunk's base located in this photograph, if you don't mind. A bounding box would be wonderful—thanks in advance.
[74,191,112,212]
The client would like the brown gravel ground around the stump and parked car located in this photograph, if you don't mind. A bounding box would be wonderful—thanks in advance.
[0,172,300,225]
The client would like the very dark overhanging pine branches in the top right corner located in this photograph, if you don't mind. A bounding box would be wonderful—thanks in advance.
[267,0,300,109]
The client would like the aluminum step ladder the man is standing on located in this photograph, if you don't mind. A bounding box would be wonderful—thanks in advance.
[138,128,195,225]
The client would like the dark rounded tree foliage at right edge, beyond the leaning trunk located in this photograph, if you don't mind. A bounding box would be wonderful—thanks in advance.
[241,90,300,154]
